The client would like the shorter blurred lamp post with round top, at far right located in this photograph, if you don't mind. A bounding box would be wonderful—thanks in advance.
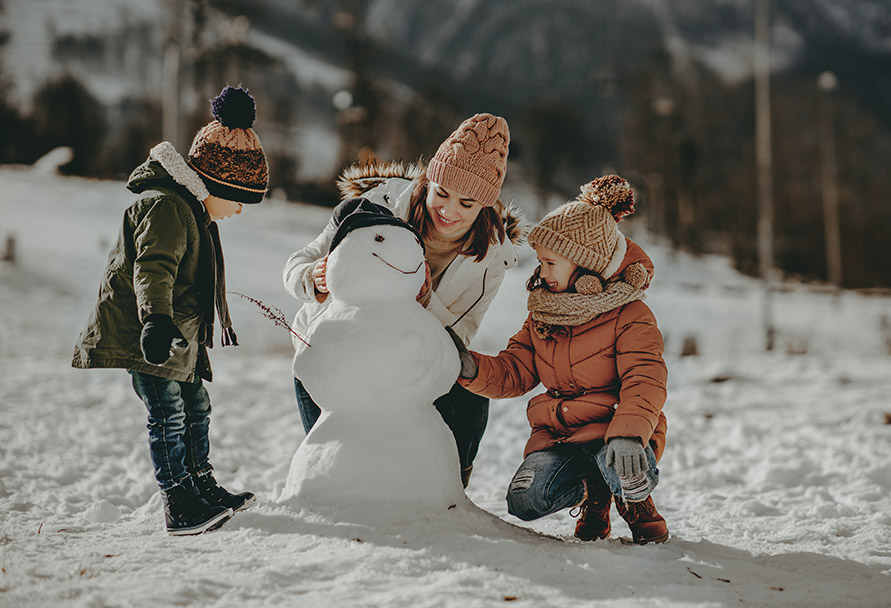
[817,72,843,288]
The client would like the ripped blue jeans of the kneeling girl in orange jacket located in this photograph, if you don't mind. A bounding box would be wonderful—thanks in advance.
[507,444,659,521]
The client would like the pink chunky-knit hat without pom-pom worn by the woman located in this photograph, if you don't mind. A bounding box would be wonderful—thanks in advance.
[427,114,510,207]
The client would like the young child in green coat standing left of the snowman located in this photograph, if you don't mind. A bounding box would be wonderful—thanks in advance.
[72,87,267,535]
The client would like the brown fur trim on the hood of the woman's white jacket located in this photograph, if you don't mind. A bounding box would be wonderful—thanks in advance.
[337,161,530,246]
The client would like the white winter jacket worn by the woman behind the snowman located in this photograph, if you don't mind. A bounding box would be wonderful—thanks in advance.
[282,177,517,366]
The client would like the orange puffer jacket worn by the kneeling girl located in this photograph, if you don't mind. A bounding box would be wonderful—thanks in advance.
[460,242,668,460]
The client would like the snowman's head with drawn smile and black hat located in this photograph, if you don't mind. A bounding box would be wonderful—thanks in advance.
[325,199,425,304]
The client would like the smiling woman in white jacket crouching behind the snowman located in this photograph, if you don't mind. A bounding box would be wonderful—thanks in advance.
[283,114,522,487]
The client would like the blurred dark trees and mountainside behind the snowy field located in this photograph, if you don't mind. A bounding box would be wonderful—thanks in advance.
[0,0,891,287]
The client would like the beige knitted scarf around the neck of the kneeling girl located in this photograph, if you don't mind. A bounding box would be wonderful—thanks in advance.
[526,275,646,340]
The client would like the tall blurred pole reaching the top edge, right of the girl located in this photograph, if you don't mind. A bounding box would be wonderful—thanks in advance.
[754,0,776,350]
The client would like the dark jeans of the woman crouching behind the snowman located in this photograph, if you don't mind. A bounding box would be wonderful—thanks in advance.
[294,378,489,470]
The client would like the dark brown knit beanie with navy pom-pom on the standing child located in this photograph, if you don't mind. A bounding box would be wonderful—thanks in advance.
[189,87,269,203]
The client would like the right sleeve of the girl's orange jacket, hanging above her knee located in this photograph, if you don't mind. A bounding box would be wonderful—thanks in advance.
[606,302,668,445]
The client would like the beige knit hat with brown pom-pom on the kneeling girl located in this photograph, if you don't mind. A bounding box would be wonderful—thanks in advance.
[527,175,634,279]
